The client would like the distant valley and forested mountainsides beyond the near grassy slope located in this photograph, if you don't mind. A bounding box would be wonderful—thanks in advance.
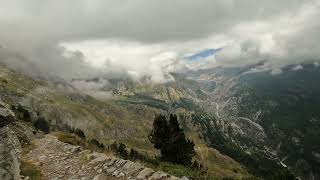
[105,61,320,179]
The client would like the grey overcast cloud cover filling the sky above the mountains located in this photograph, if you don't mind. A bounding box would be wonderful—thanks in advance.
[0,0,320,83]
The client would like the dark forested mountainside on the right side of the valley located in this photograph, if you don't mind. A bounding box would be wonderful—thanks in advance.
[185,62,320,179]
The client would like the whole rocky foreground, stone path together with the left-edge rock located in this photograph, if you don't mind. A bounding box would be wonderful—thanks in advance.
[0,97,188,180]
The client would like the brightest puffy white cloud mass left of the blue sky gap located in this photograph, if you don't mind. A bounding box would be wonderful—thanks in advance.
[61,40,179,82]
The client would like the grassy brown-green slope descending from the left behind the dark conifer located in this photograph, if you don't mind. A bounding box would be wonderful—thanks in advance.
[0,66,251,178]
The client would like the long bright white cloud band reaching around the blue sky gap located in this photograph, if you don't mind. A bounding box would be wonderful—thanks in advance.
[60,36,229,83]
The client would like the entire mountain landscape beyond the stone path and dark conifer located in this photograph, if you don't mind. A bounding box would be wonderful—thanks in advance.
[0,61,320,179]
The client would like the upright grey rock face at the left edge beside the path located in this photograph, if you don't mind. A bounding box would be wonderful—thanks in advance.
[0,100,21,180]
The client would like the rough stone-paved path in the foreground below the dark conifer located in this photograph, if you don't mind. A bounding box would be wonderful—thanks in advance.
[23,135,187,180]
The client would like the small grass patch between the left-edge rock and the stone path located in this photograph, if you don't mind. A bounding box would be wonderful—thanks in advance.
[20,161,43,180]
